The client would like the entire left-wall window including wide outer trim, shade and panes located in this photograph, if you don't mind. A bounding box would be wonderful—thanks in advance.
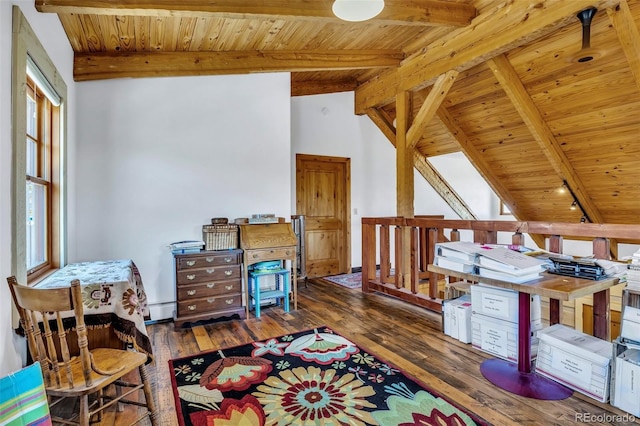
[11,6,67,283]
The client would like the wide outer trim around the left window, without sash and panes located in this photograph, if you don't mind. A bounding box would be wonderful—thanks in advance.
[11,6,67,284]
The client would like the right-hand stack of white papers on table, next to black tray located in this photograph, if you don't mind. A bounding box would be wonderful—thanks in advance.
[478,247,546,283]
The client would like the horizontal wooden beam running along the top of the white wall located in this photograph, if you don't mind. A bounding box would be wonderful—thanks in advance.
[73,50,403,81]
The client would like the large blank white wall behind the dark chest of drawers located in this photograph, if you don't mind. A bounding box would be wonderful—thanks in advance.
[75,73,292,319]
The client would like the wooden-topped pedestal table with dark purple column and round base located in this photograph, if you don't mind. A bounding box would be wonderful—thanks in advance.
[427,265,618,400]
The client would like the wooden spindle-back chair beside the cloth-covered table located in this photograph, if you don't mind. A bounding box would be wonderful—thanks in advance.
[7,276,158,426]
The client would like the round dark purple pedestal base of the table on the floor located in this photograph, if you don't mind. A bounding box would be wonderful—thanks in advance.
[480,359,573,400]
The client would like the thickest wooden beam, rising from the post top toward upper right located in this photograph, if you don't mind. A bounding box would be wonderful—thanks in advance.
[356,0,619,114]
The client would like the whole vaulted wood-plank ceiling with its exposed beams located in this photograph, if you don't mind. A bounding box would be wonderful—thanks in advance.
[35,0,640,238]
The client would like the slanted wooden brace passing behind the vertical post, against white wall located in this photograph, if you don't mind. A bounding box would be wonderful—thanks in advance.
[367,108,477,220]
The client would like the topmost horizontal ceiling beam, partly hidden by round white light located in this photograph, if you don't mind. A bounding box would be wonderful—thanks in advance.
[36,0,476,27]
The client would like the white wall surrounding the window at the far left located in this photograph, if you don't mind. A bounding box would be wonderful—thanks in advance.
[0,0,76,377]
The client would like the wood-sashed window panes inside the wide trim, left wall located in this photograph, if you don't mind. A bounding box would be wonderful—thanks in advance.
[25,75,59,276]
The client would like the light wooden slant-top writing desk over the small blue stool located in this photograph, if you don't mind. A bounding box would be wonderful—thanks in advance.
[240,223,298,318]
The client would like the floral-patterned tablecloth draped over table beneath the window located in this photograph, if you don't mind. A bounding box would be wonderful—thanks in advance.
[36,259,152,355]
